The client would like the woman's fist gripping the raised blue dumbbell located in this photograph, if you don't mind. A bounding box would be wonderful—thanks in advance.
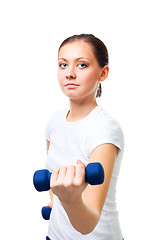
[50,160,87,204]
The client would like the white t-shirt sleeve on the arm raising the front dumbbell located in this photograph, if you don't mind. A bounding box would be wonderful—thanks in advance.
[89,119,124,153]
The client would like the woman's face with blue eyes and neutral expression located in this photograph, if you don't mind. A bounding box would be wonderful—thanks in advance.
[58,41,103,99]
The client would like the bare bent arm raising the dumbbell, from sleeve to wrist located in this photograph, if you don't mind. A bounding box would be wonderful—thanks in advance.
[59,143,119,234]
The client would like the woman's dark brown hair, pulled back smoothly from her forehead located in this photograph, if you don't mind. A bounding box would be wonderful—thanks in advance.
[58,34,109,97]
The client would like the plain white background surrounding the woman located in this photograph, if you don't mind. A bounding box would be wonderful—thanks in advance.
[0,0,160,240]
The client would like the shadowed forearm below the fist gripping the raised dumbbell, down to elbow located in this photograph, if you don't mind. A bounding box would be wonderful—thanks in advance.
[61,198,100,235]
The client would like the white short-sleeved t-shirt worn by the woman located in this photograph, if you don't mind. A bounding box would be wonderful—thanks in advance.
[46,105,124,240]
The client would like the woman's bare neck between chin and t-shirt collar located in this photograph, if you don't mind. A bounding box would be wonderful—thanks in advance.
[66,99,98,122]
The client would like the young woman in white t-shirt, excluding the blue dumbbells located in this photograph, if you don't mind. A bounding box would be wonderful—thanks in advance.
[46,34,124,240]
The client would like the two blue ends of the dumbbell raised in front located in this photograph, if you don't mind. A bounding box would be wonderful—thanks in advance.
[33,162,104,192]
